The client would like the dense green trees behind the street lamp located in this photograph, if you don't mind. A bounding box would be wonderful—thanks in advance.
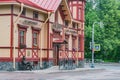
[85,0,120,61]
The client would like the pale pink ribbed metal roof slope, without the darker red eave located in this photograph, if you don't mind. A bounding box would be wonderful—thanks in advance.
[29,0,62,12]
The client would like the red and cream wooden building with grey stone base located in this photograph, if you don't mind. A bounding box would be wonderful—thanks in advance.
[0,0,85,70]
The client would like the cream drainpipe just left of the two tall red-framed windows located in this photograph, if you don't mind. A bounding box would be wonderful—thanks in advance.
[13,3,24,69]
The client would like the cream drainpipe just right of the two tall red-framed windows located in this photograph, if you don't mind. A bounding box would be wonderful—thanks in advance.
[40,12,52,68]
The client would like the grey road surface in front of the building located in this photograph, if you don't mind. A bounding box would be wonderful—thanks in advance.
[0,64,120,80]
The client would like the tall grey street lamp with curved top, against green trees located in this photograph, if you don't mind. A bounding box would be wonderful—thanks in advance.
[91,22,102,68]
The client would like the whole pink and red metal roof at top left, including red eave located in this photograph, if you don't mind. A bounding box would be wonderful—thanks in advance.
[0,0,62,12]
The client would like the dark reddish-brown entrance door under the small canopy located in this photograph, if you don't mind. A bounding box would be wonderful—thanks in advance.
[53,44,59,66]
